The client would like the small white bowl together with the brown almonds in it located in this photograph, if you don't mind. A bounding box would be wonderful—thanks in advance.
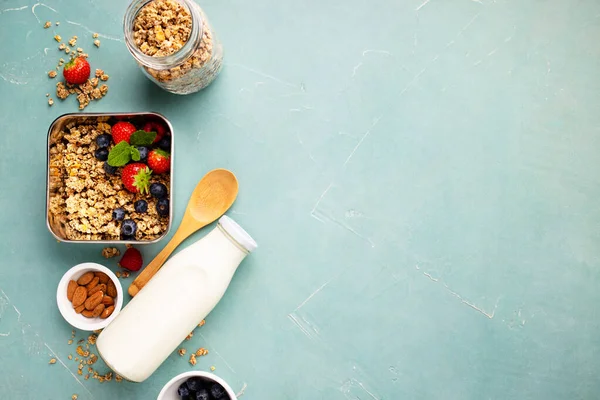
[56,263,123,331]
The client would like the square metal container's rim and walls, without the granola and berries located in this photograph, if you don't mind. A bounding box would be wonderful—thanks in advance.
[46,112,175,244]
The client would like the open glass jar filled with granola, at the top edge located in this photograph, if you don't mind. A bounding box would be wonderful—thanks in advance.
[124,0,223,94]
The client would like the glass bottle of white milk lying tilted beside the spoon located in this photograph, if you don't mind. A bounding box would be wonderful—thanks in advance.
[96,216,257,382]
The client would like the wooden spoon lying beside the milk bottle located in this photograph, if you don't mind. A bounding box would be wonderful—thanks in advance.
[128,169,238,296]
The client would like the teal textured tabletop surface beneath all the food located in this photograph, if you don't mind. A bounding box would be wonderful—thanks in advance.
[0,0,600,400]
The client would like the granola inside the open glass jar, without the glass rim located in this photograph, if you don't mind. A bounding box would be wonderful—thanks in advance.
[133,0,223,93]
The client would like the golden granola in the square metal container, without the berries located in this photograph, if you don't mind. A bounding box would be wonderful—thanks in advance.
[49,121,170,240]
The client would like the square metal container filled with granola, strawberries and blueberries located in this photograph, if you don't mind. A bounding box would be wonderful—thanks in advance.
[46,113,173,244]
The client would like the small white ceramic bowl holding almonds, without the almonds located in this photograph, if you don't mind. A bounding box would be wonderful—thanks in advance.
[56,263,123,331]
